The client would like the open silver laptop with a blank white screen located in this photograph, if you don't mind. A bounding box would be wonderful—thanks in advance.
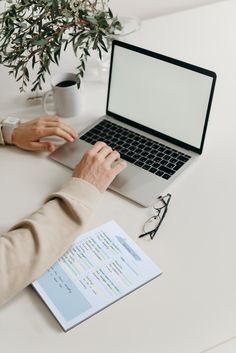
[50,40,216,207]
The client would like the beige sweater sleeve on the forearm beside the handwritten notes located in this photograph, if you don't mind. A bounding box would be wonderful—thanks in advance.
[0,178,101,305]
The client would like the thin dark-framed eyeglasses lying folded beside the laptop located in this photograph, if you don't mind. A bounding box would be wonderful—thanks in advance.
[139,194,171,239]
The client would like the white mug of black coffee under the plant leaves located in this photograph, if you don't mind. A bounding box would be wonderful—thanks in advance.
[43,73,81,117]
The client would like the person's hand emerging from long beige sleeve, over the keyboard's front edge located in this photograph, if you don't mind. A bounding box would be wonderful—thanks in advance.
[73,141,127,192]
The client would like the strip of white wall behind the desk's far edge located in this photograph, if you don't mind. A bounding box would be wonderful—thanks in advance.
[110,0,228,19]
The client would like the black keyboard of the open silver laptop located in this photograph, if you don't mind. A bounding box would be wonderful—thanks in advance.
[80,120,191,179]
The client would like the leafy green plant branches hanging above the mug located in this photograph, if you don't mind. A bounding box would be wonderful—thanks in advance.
[0,0,121,91]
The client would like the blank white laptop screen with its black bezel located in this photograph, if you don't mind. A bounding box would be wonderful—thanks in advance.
[107,41,216,152]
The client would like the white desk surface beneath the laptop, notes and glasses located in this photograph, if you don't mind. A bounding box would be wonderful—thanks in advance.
[0,1,236,353]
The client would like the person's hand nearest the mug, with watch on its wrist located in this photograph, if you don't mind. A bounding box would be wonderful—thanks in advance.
[12,117,78,152]
